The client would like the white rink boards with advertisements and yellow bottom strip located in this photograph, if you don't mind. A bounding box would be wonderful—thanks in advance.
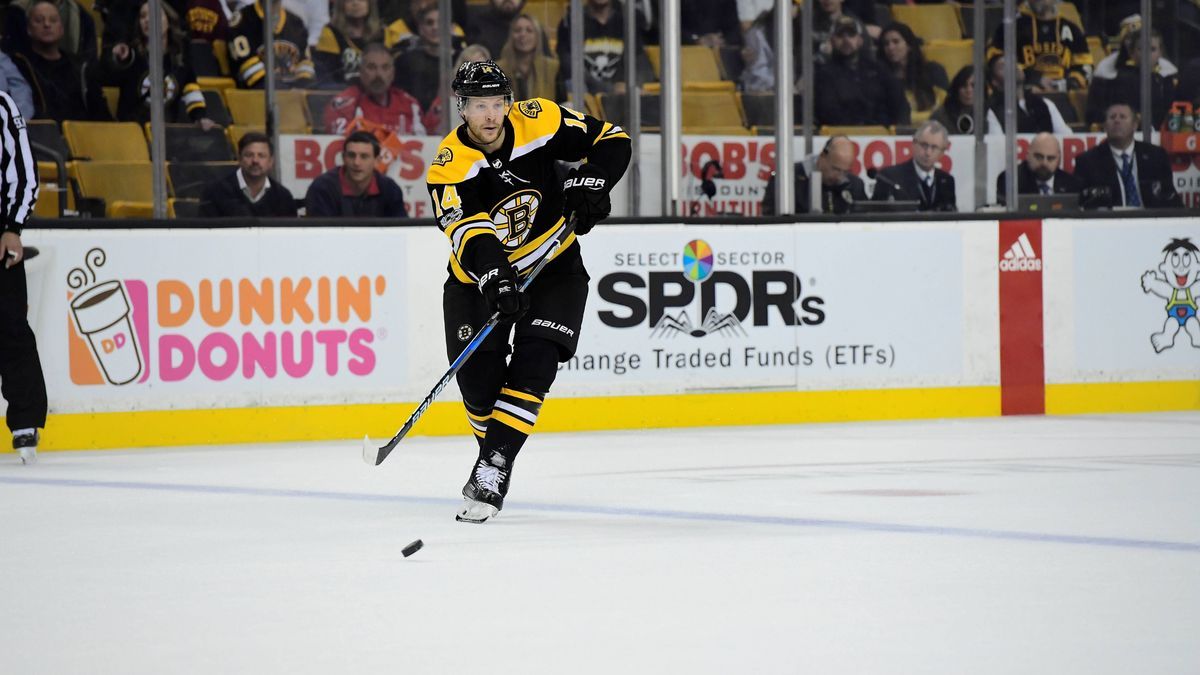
[11,219,1200,449]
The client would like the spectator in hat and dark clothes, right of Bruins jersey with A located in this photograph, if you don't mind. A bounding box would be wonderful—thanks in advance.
[1087,29,1180,127]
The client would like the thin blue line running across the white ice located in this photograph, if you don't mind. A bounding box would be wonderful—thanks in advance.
[0,477,1200,554]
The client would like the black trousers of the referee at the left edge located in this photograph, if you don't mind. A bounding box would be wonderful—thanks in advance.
[0,262,47,429]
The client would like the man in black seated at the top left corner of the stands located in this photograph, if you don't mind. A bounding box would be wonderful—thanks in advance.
[13,0,113,121]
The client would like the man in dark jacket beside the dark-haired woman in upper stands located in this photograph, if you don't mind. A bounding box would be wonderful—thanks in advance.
[814,17,910,126]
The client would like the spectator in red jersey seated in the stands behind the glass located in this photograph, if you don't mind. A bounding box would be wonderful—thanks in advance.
[325,42,425,136]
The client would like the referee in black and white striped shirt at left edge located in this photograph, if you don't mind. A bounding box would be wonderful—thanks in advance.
[0,91,46,464]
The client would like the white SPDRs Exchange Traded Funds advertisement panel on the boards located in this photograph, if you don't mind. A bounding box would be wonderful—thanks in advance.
[559,226,964,392]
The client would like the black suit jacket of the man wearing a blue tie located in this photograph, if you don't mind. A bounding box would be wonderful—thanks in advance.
[1075,141,1183,209]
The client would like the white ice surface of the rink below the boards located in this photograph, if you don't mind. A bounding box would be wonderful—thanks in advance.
[0,413,1200,675]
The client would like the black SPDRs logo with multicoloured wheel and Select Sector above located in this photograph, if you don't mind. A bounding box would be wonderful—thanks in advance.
[598,239,826,339]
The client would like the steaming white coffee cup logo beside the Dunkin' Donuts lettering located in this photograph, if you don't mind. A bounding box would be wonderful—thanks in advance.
[67,249,142,384]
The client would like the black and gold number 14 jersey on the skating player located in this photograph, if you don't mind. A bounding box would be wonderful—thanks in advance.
[426,98,631,283]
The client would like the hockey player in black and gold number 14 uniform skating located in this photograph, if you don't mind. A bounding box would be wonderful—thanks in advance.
[426,61,631,522]
